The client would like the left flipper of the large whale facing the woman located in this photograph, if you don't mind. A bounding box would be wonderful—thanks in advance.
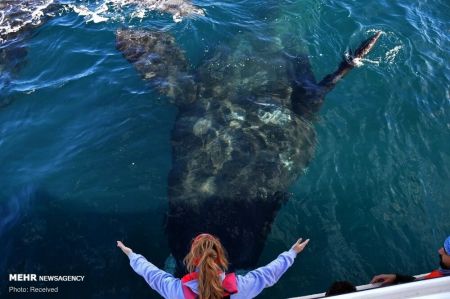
[116,29,196,105]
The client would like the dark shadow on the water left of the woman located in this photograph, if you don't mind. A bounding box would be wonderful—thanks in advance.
[0,186,167,298]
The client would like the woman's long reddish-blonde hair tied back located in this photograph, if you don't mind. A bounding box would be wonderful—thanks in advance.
[184,234,228,299]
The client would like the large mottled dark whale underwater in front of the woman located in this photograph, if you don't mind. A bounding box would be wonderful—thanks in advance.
[117,30,380,269]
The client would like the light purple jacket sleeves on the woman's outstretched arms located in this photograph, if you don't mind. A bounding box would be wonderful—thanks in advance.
[128,249,297,299]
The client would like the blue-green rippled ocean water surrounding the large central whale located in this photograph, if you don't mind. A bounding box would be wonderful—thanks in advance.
[0,0,450,298]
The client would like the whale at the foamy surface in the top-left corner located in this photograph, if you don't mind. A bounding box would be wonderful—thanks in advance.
[0,0,204,108]
